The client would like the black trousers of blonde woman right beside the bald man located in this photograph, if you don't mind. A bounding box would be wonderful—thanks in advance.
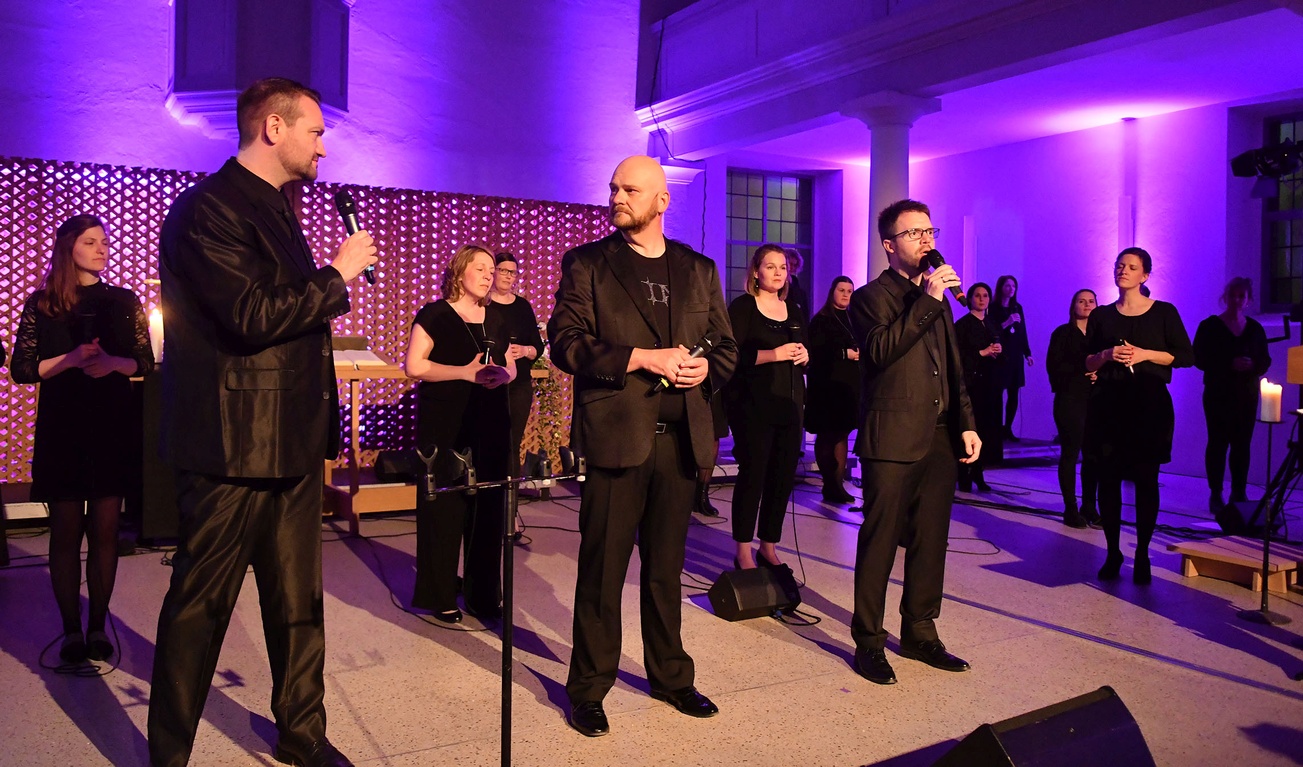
[730,414,801,543]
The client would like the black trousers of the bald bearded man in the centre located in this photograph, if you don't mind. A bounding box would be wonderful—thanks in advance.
[566,426,697,703]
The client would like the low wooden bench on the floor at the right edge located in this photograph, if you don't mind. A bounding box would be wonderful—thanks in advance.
[1167,535,1303,594]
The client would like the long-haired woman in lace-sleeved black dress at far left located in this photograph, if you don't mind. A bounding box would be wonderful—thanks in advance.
[10,215,154,663]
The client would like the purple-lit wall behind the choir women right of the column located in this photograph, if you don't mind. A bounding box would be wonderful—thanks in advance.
[911,105,1266,482]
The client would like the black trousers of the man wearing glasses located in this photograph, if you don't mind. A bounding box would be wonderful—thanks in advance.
[851,426,956,650]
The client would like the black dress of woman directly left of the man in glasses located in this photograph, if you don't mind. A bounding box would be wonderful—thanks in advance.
[805,309,860,436]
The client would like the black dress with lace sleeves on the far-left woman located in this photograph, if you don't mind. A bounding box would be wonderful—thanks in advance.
[9,281,154,503]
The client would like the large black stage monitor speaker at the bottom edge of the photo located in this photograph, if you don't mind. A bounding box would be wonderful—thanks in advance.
[933,686,1154,767]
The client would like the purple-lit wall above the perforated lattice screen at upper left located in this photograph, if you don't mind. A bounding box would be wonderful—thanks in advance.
[0,0,646,203]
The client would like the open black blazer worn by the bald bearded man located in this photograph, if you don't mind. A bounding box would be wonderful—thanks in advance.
[547,232,737,469]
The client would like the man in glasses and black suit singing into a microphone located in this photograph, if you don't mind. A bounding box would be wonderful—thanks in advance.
[850,199,981,685]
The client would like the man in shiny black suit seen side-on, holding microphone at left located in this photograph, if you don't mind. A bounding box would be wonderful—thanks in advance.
[149,78,377,767]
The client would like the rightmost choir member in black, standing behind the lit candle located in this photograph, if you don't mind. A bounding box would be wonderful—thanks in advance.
[1195,277,1272,513]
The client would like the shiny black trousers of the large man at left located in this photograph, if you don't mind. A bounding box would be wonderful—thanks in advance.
[149,469,326,767]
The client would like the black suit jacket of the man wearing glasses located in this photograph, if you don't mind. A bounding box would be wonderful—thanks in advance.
[850,270,977,461]
